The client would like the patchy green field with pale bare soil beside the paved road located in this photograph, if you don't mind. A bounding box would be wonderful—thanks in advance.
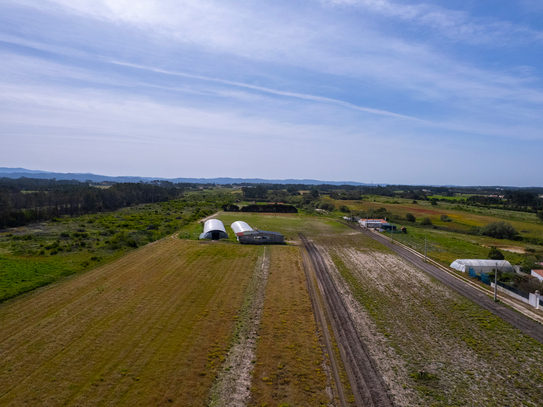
[321,236,543,406]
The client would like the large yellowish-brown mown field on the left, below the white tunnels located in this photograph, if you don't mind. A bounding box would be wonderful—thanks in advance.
[0,237,259,406]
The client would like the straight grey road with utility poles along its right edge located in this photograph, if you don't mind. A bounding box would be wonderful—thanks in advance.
[348,225,543,344]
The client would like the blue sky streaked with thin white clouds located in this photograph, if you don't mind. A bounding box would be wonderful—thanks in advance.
[0,0,543,186]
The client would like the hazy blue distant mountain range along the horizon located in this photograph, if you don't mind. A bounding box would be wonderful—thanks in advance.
[0,167,374,185]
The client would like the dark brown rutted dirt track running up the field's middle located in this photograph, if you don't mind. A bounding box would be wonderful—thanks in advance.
[300,234,393,407]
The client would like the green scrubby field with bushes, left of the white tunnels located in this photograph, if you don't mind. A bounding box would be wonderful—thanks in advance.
[0,200,214,302]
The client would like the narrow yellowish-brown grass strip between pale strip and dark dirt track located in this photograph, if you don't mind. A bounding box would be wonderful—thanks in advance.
[250,246,337,407]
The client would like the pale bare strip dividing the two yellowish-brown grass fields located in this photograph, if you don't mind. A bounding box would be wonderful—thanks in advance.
[209,247,270,407]
